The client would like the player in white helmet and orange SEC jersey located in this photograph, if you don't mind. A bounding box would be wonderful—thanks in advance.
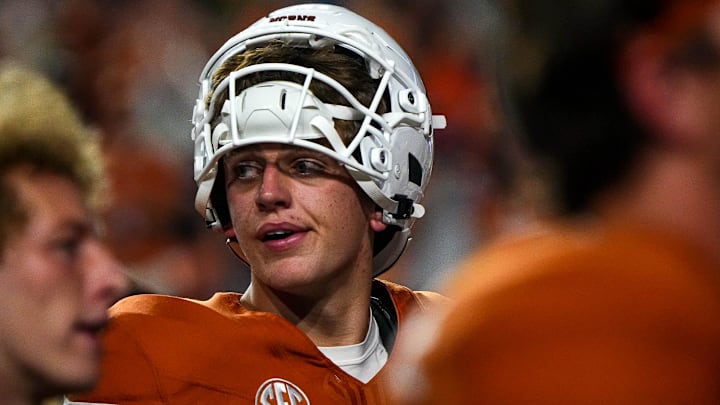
[72,4,445,404]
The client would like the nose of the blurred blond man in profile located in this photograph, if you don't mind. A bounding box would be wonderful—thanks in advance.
[85,241,130,308]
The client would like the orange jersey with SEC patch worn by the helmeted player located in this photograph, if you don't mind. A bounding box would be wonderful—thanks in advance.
[71,282,442,405]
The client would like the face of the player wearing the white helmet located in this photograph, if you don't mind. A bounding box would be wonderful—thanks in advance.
[224,143,385,295]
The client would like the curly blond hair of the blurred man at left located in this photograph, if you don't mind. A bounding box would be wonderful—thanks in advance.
[0,62,107,252]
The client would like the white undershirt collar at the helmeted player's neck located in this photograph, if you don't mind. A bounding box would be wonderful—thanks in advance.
[318,314,388,383]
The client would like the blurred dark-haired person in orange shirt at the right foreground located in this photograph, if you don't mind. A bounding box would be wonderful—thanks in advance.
[392,0,720,404]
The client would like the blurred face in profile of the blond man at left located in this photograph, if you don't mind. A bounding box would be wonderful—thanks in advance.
[0,169,127,395]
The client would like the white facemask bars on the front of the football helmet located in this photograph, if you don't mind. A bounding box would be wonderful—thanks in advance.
[195,63,442,221]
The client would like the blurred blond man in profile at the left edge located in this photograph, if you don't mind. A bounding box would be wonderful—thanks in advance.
[0,61,127,405]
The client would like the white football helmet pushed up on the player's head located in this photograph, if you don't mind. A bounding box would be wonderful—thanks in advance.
[192,4,445,275]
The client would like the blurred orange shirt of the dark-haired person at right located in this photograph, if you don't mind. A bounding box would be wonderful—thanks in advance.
[394,219,720,405]
